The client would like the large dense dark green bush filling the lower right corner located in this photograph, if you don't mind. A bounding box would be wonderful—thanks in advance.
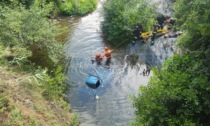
[133,55,210,126]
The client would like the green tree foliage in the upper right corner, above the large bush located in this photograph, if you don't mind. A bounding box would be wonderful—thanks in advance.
[174,0,210,51]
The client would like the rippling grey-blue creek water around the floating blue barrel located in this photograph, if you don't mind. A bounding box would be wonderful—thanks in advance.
[65,0,176,126]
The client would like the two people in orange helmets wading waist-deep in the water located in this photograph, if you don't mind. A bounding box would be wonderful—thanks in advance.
[94,47,112,64]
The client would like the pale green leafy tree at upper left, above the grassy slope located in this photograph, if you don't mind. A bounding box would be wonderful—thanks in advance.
[0,1,62,67]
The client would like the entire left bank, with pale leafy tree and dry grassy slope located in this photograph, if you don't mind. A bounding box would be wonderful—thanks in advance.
[0,0,79,126]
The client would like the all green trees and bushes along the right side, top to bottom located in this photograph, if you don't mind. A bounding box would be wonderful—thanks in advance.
[133,0,210,126]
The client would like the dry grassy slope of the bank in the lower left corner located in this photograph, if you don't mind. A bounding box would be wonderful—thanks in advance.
[0,66,78,126]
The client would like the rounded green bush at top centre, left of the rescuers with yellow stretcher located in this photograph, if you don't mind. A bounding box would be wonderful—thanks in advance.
[102,0,157,45]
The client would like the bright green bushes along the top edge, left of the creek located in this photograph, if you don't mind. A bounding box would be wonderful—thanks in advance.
[0,0,98,17]
